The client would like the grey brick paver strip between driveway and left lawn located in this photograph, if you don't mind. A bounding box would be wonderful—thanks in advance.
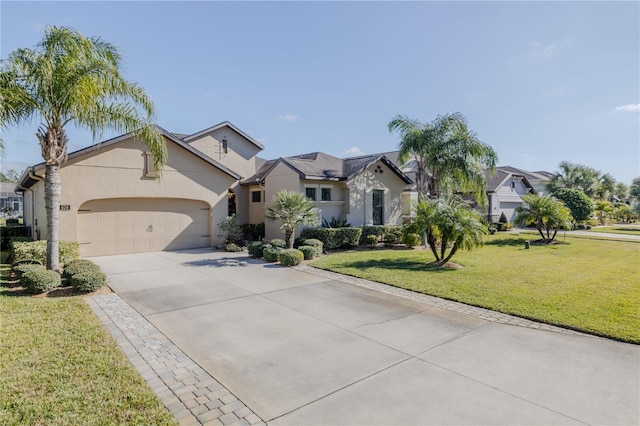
[87,294,265,426]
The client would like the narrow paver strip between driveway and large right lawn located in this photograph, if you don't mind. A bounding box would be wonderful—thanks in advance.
[293,265,585,335]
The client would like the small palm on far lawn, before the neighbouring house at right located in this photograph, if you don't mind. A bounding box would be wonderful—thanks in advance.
[514,194,572,243]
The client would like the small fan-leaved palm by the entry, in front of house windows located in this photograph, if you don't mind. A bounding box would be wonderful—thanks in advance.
[266,189,320,248]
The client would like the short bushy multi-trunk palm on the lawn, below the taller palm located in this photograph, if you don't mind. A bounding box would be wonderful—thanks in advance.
[415,197,488,266]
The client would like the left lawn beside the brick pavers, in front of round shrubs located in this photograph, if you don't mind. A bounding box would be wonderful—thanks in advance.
[0,254,176,425]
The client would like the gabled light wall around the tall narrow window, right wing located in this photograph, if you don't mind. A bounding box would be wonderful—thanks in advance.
[347,161,406,226]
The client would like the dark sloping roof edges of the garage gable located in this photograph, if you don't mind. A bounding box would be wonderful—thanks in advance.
[16,125,241,192]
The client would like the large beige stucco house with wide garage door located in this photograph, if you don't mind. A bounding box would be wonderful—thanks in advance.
[15,122,412,256]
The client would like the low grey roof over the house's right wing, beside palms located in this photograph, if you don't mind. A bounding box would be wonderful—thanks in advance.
[241,152,413,185]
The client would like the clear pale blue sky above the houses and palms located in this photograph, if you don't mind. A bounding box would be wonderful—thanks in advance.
[0,0,640,184]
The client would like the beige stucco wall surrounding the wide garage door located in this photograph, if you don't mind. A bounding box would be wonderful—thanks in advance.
[28,138,237,250]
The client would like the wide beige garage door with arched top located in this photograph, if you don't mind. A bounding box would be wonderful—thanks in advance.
[78,198,210,256]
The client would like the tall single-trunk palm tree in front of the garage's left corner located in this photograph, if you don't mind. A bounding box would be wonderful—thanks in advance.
[0,26,167,271]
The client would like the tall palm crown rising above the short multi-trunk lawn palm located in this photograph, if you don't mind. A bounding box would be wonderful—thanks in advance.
[388,113,498,202]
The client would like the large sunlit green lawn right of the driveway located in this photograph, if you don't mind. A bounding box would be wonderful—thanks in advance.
[312,234,640,343]
